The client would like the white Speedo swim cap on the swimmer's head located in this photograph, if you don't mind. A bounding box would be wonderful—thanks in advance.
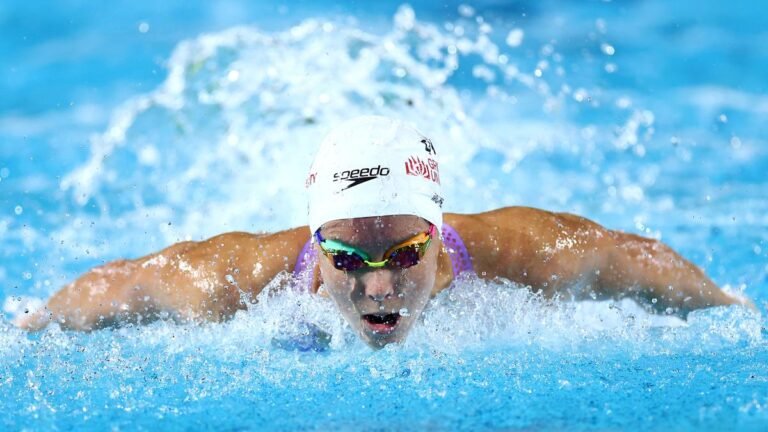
[305,116,443,233]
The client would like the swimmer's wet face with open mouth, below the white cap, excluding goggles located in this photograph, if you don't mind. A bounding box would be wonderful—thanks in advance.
[316,215,442,348]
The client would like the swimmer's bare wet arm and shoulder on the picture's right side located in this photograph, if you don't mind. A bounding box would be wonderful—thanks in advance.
[468,207,756,317]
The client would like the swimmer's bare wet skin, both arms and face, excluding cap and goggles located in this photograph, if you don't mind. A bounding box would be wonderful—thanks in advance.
[16,207,754,347]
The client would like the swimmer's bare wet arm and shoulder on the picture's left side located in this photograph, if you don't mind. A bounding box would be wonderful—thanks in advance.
[15,227,309,331]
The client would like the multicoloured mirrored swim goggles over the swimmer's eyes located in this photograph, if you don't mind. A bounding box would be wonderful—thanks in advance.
[315,224,436,271]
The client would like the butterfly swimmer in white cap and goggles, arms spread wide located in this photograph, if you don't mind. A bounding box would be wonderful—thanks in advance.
[16,116,754,348]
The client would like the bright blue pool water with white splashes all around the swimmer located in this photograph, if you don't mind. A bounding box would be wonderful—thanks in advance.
[0,0,768,430]
